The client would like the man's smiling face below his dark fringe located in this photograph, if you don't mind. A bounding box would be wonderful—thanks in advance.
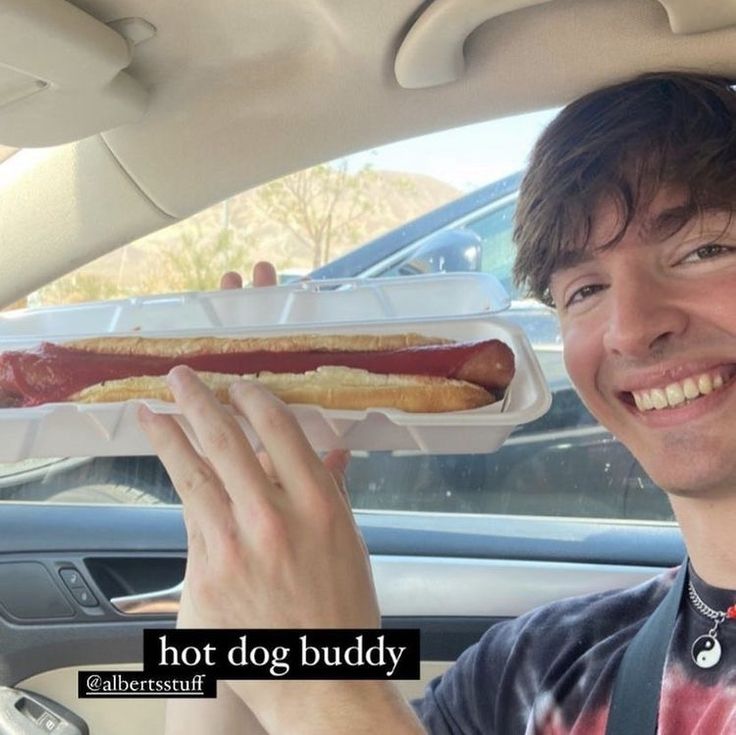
[550,190,736,497]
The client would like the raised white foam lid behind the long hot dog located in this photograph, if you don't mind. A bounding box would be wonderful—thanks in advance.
[0,273,509,342]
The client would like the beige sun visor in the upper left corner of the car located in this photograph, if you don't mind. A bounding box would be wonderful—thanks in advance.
[0,0,147,148]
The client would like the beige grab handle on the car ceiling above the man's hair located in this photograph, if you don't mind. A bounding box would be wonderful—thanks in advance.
[394,0,736,89]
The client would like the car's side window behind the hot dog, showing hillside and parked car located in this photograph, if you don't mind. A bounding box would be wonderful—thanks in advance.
[0,113,672,521]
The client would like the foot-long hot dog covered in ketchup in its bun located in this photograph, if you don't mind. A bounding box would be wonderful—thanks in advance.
[0,334,514,412]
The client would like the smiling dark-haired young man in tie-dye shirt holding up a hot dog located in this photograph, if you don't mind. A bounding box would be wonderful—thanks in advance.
[141,74,736,735]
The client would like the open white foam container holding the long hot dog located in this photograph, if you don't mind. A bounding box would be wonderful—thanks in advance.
[0,273,551,462]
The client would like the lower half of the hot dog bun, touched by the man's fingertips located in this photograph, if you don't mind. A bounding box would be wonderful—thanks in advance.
[69,366,495,413]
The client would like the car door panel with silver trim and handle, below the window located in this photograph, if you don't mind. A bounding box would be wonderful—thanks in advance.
[0,503,682,735]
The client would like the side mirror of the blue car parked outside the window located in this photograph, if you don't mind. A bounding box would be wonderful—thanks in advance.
[395,230,482,276]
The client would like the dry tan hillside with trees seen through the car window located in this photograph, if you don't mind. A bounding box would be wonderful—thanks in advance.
[26,159,461,308]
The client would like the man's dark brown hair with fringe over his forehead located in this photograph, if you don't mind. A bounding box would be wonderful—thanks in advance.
[514,72,736,304]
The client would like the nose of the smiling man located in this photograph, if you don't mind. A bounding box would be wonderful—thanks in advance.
[603,277,688,357]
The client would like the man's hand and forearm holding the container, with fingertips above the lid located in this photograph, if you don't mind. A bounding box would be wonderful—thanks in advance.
[140,269,423,734]
